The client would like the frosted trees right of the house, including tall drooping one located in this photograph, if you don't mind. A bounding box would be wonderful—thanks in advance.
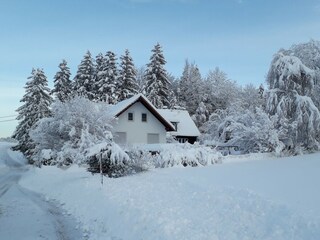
[202,40,320,154]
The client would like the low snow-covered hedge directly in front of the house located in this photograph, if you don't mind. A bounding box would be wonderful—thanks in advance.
[128,143,222,170]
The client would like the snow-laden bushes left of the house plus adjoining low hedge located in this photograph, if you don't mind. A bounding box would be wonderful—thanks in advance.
[30,97,221,177]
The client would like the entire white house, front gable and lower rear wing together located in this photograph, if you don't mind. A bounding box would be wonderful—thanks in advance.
[111,94,200,145]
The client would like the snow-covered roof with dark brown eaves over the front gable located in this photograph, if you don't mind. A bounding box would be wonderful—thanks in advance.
[110,93,175,131]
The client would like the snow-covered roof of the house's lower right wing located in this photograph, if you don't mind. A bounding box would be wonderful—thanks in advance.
[158,109,200,137]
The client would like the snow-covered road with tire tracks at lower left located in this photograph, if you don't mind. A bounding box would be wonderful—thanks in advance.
[0,143,82,240]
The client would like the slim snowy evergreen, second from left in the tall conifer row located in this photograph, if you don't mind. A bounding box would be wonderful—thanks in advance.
[51,60,72,102]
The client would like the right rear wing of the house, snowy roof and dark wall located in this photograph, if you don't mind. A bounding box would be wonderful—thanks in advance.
[158,109,200,144]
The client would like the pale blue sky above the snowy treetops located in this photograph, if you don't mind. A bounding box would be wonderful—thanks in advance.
[0,0,320,137]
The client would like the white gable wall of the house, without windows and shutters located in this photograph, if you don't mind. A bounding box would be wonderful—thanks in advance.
[113,102,166,144]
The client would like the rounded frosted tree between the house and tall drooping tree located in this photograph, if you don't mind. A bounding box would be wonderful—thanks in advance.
[202,108,284,154]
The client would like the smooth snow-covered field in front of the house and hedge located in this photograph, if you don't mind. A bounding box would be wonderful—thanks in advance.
[0,142,320,240]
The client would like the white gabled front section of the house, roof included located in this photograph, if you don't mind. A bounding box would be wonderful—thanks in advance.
[111,94,175,145]
